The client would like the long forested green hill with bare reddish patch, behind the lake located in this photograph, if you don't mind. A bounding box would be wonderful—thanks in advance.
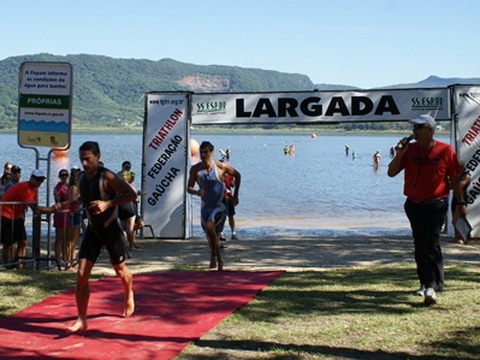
[0,54,315,129]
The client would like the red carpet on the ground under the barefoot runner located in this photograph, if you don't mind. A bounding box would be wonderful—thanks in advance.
[0,271,282,360]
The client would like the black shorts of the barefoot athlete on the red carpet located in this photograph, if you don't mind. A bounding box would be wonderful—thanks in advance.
[78,219,126,265]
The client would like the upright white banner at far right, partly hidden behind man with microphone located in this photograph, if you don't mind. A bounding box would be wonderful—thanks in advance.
[453,86,480,237]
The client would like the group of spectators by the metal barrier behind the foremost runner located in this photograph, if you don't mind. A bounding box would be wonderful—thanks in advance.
[0,153,145,270]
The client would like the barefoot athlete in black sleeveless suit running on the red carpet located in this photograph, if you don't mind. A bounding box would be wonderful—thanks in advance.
[67,141,137,332]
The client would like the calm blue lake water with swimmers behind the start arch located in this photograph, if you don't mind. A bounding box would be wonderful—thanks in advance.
[0,132,449,236]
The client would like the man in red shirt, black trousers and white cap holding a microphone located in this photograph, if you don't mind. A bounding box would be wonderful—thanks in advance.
[388,115,467,305]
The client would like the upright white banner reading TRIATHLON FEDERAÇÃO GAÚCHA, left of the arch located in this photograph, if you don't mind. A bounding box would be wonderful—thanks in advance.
[142,93,190,239]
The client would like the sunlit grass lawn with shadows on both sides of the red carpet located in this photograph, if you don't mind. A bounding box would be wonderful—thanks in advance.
[0,263,480,359]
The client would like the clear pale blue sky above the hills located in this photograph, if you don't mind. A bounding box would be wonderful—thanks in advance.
[0,0,480,89]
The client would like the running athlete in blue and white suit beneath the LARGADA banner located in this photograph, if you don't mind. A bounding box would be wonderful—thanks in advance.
[188,141,241,270]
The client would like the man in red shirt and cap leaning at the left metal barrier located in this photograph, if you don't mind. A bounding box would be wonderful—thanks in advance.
[1,169,59,269]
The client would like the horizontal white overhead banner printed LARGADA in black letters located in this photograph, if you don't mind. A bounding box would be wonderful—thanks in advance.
[192,88,450,125]
